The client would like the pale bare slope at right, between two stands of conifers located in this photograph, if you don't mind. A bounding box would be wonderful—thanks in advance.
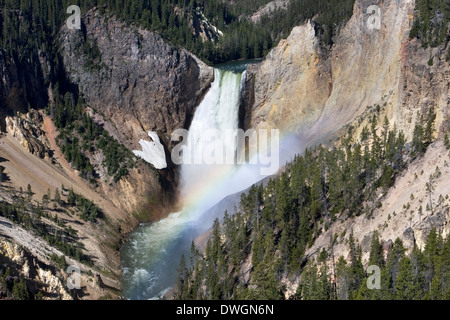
[308,140,450,261]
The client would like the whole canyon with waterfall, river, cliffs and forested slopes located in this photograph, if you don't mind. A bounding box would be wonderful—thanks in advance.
[0,0,450,300]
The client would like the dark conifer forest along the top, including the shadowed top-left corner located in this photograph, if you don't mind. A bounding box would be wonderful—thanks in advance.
[0,0,354,67]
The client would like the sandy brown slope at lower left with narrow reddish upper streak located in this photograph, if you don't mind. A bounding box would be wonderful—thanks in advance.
[0,125,127,298]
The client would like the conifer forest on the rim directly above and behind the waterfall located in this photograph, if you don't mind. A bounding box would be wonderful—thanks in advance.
[89,0,354,63]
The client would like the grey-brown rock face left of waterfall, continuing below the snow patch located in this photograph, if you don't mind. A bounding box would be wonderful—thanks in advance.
[59,9,214,220]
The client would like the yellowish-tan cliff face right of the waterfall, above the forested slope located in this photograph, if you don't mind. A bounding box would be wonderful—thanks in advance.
[247,0,450,147]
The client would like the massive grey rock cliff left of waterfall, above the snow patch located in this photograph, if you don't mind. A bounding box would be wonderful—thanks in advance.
[60,10,214,150]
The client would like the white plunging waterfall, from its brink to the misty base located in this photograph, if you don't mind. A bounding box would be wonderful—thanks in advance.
[180,69,245,213]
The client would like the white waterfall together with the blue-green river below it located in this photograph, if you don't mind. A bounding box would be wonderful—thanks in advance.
[122,64,250,299]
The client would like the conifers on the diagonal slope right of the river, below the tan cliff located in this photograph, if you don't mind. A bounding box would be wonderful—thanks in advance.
[175,112,442,299]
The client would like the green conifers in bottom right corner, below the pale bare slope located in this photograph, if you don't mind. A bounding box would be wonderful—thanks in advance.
[296,229,450,300]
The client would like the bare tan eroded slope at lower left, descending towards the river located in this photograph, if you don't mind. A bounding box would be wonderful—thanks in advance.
[0,134,124,298]
